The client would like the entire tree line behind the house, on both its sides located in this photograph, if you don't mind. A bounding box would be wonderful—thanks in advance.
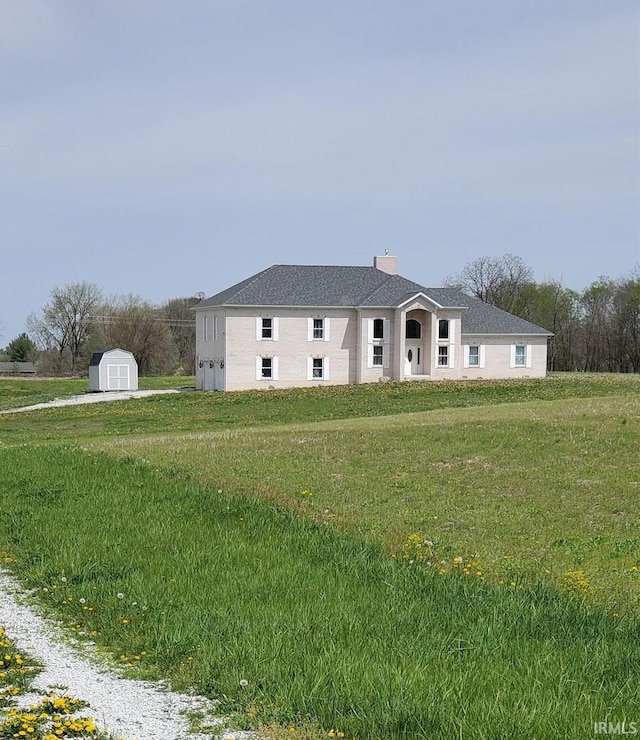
[4,254,640,375]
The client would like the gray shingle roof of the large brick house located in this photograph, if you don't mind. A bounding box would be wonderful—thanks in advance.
[196,265,549,334]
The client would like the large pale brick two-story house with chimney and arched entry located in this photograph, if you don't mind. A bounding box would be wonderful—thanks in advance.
[195,255,550,391]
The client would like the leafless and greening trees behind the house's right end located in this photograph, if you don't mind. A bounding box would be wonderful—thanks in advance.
[447,254,640,373]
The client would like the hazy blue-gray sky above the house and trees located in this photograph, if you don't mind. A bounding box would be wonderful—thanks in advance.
[0,0,640,346]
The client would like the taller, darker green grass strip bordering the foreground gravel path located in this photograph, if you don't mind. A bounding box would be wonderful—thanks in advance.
[0,446,640,739]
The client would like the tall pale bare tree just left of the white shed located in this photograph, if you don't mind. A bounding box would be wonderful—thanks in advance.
[27,282,102,372]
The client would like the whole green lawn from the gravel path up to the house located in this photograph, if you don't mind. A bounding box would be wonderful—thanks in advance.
[0,376,640,738]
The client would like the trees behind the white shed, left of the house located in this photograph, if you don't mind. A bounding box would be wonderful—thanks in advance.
[0,282,199,375]
